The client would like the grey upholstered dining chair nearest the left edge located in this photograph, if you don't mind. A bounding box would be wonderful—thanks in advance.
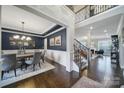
[1,54,21,79]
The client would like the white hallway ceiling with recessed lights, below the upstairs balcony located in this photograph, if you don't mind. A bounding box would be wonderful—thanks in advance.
[75,15,121,39]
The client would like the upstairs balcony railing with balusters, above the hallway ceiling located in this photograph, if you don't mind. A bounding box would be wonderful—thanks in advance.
[76,5,117,23]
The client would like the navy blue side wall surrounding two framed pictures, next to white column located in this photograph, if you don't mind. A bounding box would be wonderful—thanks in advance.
[47,29,66,51]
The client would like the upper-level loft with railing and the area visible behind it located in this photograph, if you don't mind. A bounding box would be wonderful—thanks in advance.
[67,5,117,23]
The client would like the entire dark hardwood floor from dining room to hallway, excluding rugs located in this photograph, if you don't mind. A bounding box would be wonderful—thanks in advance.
[3,57,124,88]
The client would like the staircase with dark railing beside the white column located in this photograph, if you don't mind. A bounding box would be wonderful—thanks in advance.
[73,39,90,72]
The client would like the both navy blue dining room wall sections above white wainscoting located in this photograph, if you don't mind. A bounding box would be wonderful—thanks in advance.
[2,29,66,51]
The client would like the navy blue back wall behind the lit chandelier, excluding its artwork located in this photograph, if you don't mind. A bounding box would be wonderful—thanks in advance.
[2,32,44,50]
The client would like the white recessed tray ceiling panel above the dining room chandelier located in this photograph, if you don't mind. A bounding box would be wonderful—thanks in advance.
[2,5,56,34]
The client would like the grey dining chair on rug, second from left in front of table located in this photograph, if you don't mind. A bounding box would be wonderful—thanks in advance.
[25,52,41,71]
